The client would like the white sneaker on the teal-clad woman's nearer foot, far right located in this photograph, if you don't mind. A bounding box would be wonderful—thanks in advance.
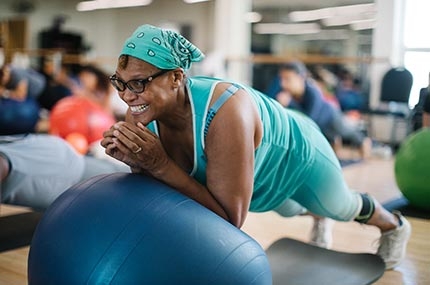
[377,211,411,270]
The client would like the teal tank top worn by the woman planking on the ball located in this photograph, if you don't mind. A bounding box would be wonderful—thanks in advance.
[148,76,324,212]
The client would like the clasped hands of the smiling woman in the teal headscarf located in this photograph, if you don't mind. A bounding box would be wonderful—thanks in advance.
[101,122,170,177]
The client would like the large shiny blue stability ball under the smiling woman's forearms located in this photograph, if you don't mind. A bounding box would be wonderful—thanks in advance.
[28,173,272,285]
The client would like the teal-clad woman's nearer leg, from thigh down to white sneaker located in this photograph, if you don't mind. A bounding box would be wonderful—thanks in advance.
[291,136,410,269]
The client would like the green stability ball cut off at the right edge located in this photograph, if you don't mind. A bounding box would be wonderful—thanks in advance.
[394,129,430,210]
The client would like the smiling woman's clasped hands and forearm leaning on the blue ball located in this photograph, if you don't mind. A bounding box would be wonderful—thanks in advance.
[101,118,229,220]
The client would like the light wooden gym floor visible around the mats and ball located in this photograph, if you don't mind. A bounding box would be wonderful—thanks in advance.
[0,155,430,285]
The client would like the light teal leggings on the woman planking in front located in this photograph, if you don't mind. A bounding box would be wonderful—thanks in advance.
[274,137,362,221]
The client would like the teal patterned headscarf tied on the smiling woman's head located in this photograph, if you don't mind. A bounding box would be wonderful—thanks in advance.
[121,25,204,70]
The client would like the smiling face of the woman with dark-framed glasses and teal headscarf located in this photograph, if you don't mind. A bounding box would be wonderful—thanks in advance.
[115,57,176,125]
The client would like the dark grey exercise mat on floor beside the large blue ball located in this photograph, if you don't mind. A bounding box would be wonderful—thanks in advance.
[266,235,385,285]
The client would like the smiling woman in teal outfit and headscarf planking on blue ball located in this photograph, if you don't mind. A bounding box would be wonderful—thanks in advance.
[101,25,410,269]
